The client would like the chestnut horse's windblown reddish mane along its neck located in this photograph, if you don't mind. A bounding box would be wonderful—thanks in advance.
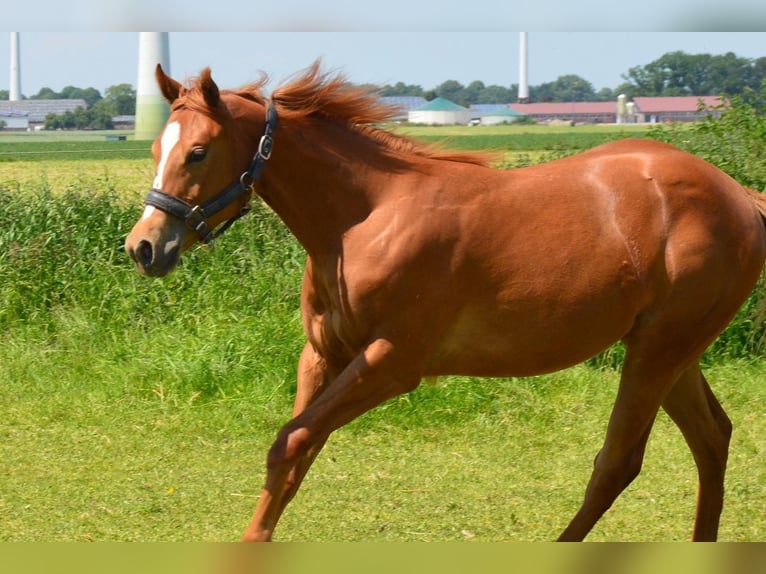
[185,60,493,169]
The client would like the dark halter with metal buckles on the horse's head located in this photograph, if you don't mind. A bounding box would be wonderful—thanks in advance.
[144,100,279,243]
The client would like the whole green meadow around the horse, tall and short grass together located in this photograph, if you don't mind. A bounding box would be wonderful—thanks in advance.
[0,127,766,541]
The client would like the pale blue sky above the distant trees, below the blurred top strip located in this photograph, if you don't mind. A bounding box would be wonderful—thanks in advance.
[0,31,766,96]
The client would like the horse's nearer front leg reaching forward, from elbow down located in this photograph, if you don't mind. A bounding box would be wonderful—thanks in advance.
[243,339,420,541]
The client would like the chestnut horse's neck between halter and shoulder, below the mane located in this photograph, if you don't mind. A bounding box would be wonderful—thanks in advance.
[259,126,384,264]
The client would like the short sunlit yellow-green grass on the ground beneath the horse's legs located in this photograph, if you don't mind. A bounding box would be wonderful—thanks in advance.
[0,354,766,541]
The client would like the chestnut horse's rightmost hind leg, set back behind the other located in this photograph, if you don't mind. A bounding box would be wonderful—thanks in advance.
[662,364,731,541]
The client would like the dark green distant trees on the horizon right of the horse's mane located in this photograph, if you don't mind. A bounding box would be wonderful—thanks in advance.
[382,51,766,106]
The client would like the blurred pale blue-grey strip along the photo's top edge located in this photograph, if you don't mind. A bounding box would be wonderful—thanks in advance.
[3,0,766,32]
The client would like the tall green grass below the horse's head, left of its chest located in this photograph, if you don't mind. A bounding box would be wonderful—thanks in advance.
[0,177,304,410]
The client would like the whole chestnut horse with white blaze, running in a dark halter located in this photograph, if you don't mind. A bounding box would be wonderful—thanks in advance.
[125,63,766,540]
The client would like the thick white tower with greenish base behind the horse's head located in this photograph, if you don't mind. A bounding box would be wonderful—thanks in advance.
[135,32,170,140]
